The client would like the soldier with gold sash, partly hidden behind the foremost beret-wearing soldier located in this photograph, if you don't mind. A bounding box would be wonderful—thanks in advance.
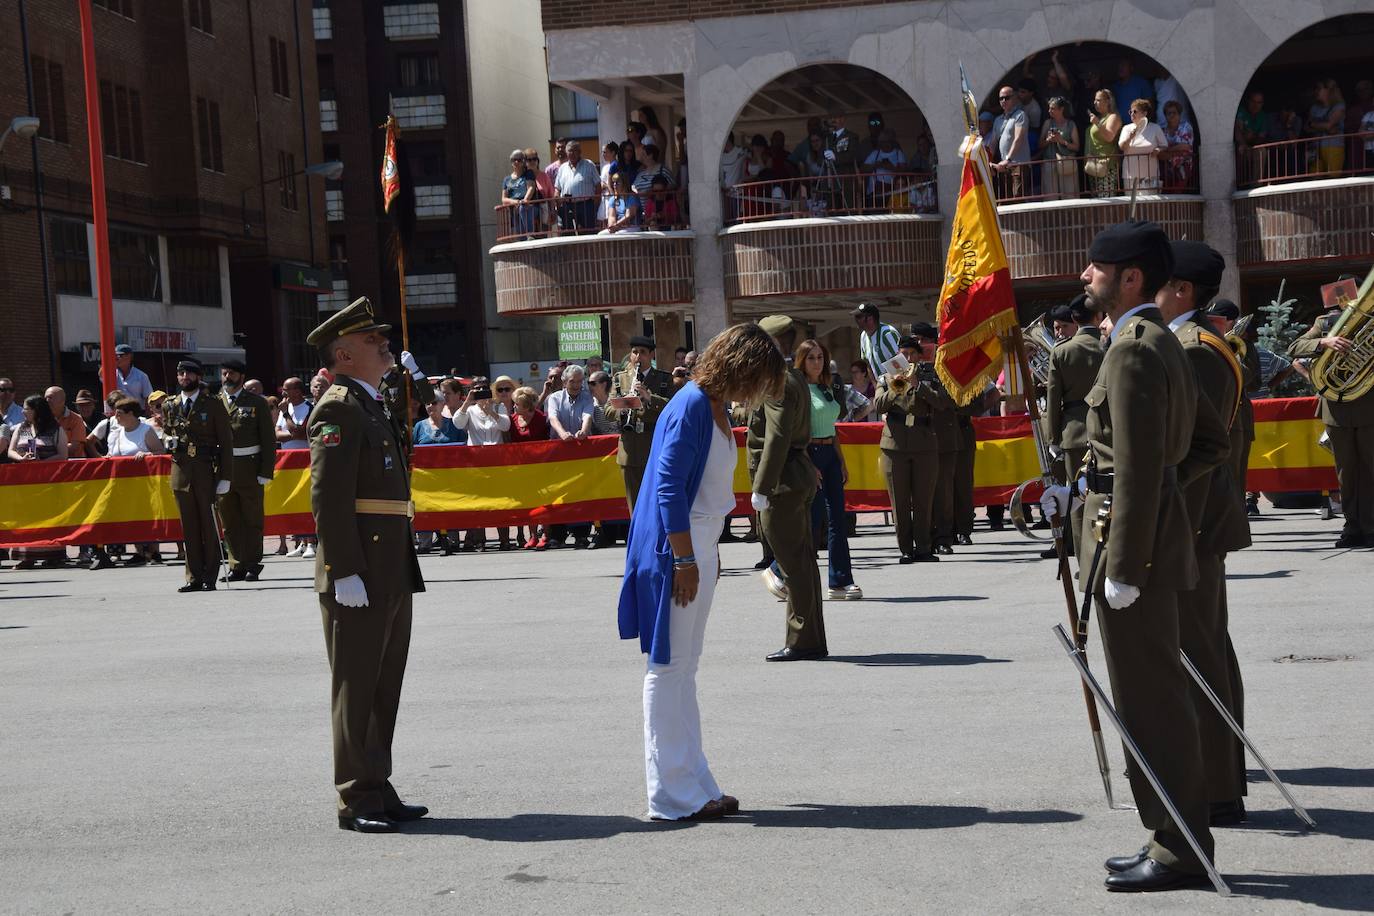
[1156,242,1250,827]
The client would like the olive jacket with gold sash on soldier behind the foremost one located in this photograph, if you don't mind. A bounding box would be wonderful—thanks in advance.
[1173,313,1250,556]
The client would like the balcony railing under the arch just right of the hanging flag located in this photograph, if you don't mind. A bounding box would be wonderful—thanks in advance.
[992,151,1198,205]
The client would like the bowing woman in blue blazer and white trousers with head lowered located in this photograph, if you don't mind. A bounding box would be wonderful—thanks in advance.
[620,324,787,820]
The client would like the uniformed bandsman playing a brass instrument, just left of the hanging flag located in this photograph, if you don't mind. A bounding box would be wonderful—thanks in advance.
[874,336,949,563]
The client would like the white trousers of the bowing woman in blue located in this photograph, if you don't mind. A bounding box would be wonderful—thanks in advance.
[644,516,724,820]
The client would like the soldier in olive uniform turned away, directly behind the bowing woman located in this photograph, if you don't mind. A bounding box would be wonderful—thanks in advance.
[745,314,830,662]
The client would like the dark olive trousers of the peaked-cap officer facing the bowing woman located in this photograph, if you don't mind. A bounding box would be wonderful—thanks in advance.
[320,593,412,816]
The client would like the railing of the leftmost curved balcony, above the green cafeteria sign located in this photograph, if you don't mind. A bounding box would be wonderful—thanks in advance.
[496,191,687,242]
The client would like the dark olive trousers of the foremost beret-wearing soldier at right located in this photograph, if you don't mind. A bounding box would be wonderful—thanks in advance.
[1094,587,1213,873]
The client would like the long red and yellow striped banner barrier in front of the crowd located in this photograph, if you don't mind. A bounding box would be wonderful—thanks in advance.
[0,398,1337,547]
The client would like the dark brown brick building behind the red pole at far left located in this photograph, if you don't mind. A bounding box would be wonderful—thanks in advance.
[0,0,326,393]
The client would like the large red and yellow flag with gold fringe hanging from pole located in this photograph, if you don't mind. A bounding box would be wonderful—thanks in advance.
[936,149,1017,404]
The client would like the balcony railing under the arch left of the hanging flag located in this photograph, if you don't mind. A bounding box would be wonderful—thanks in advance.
[723,172,940,225]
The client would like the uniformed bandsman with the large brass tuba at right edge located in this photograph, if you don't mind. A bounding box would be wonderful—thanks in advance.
[1286,273,1374,548]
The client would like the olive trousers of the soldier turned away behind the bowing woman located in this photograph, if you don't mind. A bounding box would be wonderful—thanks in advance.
[758,490,826,650]
